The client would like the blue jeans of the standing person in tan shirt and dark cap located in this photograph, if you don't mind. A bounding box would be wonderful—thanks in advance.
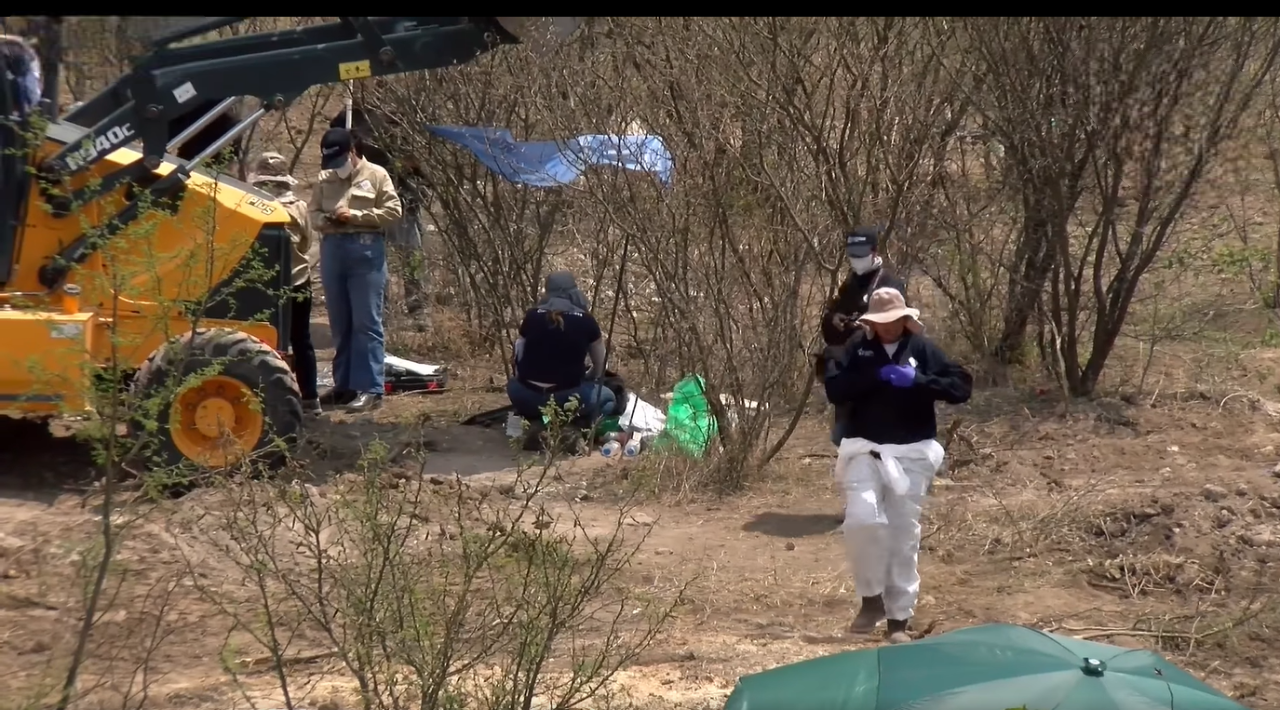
[320,234,387,394]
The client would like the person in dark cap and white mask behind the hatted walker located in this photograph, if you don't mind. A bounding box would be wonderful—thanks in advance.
[818,226,906,446]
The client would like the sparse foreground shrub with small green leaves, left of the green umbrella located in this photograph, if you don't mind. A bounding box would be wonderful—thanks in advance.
[184,429,682,710]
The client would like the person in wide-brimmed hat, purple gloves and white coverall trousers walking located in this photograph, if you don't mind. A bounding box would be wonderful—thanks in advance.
[824,288,973,643]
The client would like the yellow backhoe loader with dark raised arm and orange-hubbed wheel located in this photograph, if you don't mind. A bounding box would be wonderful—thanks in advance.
[0,17,584,473]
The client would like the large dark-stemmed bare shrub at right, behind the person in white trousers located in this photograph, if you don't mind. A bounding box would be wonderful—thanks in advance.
[937,18,1280,395]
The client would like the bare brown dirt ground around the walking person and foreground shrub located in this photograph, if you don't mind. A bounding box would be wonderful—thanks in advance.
[0,342,1280,710]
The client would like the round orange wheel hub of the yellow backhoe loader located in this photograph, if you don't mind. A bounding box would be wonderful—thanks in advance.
[169,375,265,468]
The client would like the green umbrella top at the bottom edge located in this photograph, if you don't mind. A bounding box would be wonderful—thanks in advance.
[724,624,1244,710]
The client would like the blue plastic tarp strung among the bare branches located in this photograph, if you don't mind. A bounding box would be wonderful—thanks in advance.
[426,125,675,187]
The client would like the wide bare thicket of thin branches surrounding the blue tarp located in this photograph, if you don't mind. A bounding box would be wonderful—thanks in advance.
[366,18,964,490]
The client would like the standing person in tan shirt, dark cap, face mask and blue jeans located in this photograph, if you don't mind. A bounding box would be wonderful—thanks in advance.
[310,128,403,412]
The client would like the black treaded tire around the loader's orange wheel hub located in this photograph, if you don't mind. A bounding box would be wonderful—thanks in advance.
[129,327,303,471]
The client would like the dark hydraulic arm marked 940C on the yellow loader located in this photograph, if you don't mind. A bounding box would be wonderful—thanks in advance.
[27,17,581,289]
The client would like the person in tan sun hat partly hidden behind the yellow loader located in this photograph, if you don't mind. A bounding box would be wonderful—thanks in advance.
[248,152,320,414]
